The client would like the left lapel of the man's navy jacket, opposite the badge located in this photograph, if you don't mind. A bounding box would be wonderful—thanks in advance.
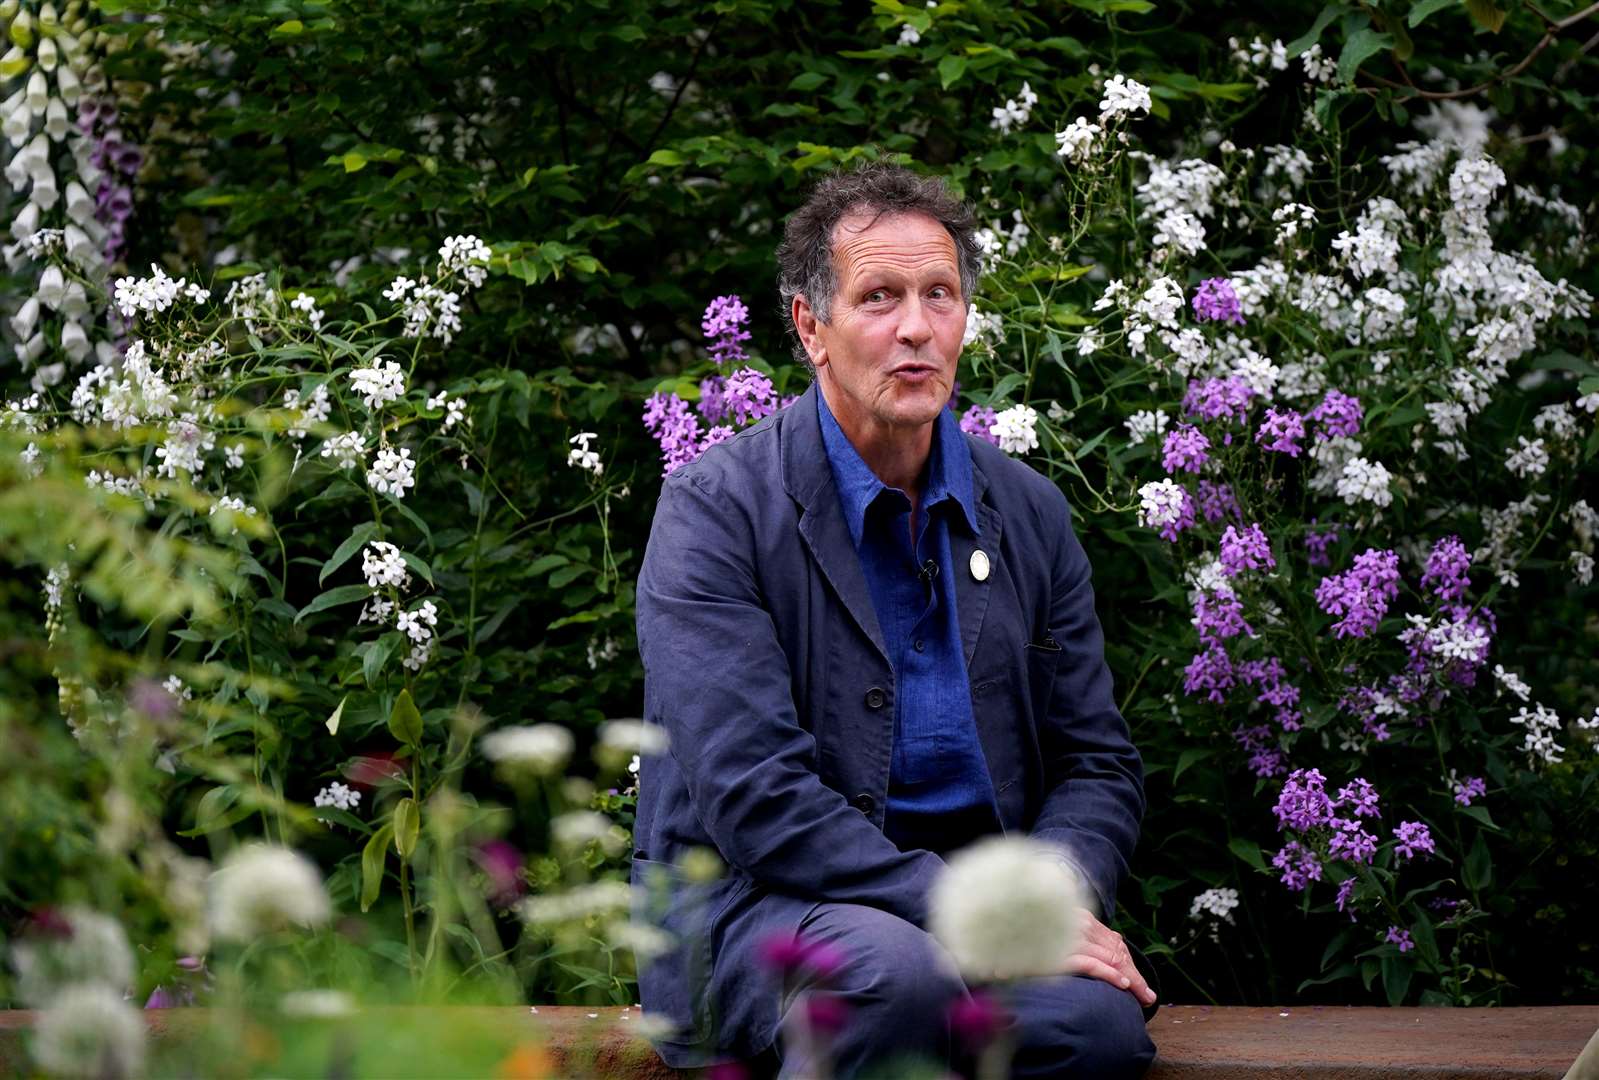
[780,382,895,662]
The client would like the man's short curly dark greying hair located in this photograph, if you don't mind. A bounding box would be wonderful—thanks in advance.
[777,162,982,365]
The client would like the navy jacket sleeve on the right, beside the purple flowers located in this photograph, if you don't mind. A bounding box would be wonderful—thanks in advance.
[1033,490,1145,922]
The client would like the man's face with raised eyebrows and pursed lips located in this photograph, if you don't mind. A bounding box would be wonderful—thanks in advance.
[801,213,966,438]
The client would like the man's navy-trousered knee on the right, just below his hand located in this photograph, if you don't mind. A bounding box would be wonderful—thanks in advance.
[1015,974,1154,1078]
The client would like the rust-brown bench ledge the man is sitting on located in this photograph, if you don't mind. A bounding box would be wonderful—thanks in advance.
[0,1005,1599,1080]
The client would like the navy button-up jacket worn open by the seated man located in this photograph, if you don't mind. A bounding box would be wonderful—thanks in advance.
[633,386,1145,1067]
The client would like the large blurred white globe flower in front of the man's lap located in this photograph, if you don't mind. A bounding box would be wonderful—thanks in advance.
[927,835,1084,979]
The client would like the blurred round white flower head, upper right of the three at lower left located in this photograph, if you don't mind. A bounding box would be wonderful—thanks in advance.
[209,843,333,942]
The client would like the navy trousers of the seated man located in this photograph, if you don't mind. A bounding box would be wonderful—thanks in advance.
[732,902,1154,1080]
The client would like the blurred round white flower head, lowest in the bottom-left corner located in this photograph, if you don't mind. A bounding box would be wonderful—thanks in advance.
[34,982,146,1077]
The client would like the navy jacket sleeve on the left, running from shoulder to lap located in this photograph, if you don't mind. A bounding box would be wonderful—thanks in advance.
[638,466,943,925]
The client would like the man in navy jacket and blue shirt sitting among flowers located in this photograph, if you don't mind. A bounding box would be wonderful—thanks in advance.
[633,165,1154,1077]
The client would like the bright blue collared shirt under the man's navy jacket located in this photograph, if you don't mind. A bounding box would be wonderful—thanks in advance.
[817,392,996,851]
